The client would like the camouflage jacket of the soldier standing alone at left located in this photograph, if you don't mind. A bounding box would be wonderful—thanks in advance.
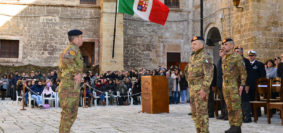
[58,44,83,86]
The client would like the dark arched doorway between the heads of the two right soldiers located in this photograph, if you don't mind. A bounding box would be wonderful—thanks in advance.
[206,27,222,63]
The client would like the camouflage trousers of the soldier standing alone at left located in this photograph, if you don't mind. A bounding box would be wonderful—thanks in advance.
[59,90,80,133]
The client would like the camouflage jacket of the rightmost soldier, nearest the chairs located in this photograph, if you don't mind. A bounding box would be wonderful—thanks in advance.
[222,52,247,86]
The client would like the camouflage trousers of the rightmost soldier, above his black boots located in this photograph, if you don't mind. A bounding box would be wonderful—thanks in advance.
[222,82,243,126]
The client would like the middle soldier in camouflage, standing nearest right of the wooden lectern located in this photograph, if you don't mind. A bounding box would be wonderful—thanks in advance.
[185,36,213,133]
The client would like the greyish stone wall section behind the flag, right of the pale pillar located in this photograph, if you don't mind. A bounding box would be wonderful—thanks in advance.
[124,0,191,69]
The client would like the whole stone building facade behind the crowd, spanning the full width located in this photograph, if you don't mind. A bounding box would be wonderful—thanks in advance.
[0,0,283,72]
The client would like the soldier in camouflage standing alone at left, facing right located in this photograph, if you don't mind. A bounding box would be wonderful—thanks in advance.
[58,30,83,133]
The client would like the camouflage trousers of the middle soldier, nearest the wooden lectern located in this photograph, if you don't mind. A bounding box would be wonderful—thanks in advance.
[190,86,209,133]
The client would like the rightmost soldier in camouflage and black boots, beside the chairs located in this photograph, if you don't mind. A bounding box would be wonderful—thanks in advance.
[222,38,247,133]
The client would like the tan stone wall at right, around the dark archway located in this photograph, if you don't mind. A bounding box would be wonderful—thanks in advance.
[192,0,283,62]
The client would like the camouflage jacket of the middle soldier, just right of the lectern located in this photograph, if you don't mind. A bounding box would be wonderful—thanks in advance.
[184,49,213,92]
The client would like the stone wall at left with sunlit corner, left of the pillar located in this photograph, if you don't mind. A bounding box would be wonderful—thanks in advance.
[0,0,100,66]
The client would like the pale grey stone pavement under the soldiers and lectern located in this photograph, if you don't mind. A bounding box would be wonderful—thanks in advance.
[0,100,283,133]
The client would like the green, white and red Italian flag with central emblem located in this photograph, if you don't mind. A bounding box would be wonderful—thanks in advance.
[118,0,169,25]
